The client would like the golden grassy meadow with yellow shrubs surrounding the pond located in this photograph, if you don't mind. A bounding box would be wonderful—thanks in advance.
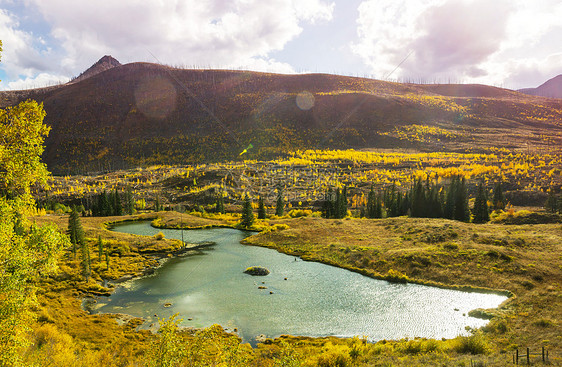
[26,149,562,366]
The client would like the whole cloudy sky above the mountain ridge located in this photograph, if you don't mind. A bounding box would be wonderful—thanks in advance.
[0,0,562,90]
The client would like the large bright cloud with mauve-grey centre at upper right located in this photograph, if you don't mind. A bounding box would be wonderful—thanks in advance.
[352,0,562,88]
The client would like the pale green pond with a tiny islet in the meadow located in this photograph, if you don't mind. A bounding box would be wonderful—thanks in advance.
[94,222,507,342]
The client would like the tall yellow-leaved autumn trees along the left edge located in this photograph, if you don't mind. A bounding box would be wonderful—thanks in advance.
[0,44,68,366]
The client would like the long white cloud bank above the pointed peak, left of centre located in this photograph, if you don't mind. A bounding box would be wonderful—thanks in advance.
[10,0,334,82]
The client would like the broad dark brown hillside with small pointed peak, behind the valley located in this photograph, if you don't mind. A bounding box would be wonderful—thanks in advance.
[0,56,562,174]
